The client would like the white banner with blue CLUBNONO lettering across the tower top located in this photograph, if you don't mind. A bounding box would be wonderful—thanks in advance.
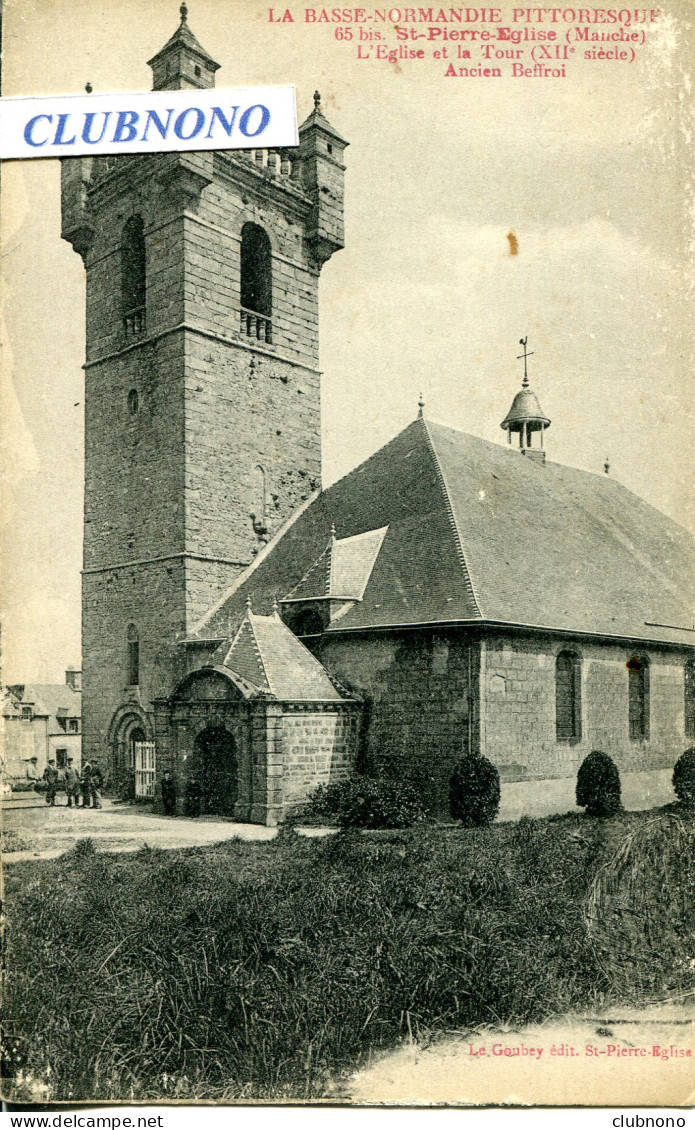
[0,86,298,159]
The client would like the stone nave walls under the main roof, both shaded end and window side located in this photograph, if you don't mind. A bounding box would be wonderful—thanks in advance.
[315,632,692,812]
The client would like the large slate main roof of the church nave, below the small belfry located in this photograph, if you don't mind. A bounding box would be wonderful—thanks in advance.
[188,418,695,645]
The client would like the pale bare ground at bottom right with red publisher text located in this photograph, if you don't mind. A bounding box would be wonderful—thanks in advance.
[347,1005,695,1106]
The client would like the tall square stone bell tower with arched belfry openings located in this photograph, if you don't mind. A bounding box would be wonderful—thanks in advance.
[62,5,347,793]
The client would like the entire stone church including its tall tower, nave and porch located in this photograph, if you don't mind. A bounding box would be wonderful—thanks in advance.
[62,5,695,824]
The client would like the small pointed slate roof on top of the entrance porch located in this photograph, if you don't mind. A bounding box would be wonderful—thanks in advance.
[210,609,342,702]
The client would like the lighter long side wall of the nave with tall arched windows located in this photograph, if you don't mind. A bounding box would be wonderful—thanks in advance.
[480,634,687,781]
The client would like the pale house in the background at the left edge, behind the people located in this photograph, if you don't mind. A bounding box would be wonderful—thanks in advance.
[2,667,82,784]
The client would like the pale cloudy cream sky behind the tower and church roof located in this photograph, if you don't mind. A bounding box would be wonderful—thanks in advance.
[0,0,695,683]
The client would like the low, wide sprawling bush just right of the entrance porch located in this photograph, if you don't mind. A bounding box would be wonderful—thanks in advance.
[309,775,426,828]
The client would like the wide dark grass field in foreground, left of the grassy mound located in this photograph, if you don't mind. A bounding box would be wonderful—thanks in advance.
[5,814,692,1102]
